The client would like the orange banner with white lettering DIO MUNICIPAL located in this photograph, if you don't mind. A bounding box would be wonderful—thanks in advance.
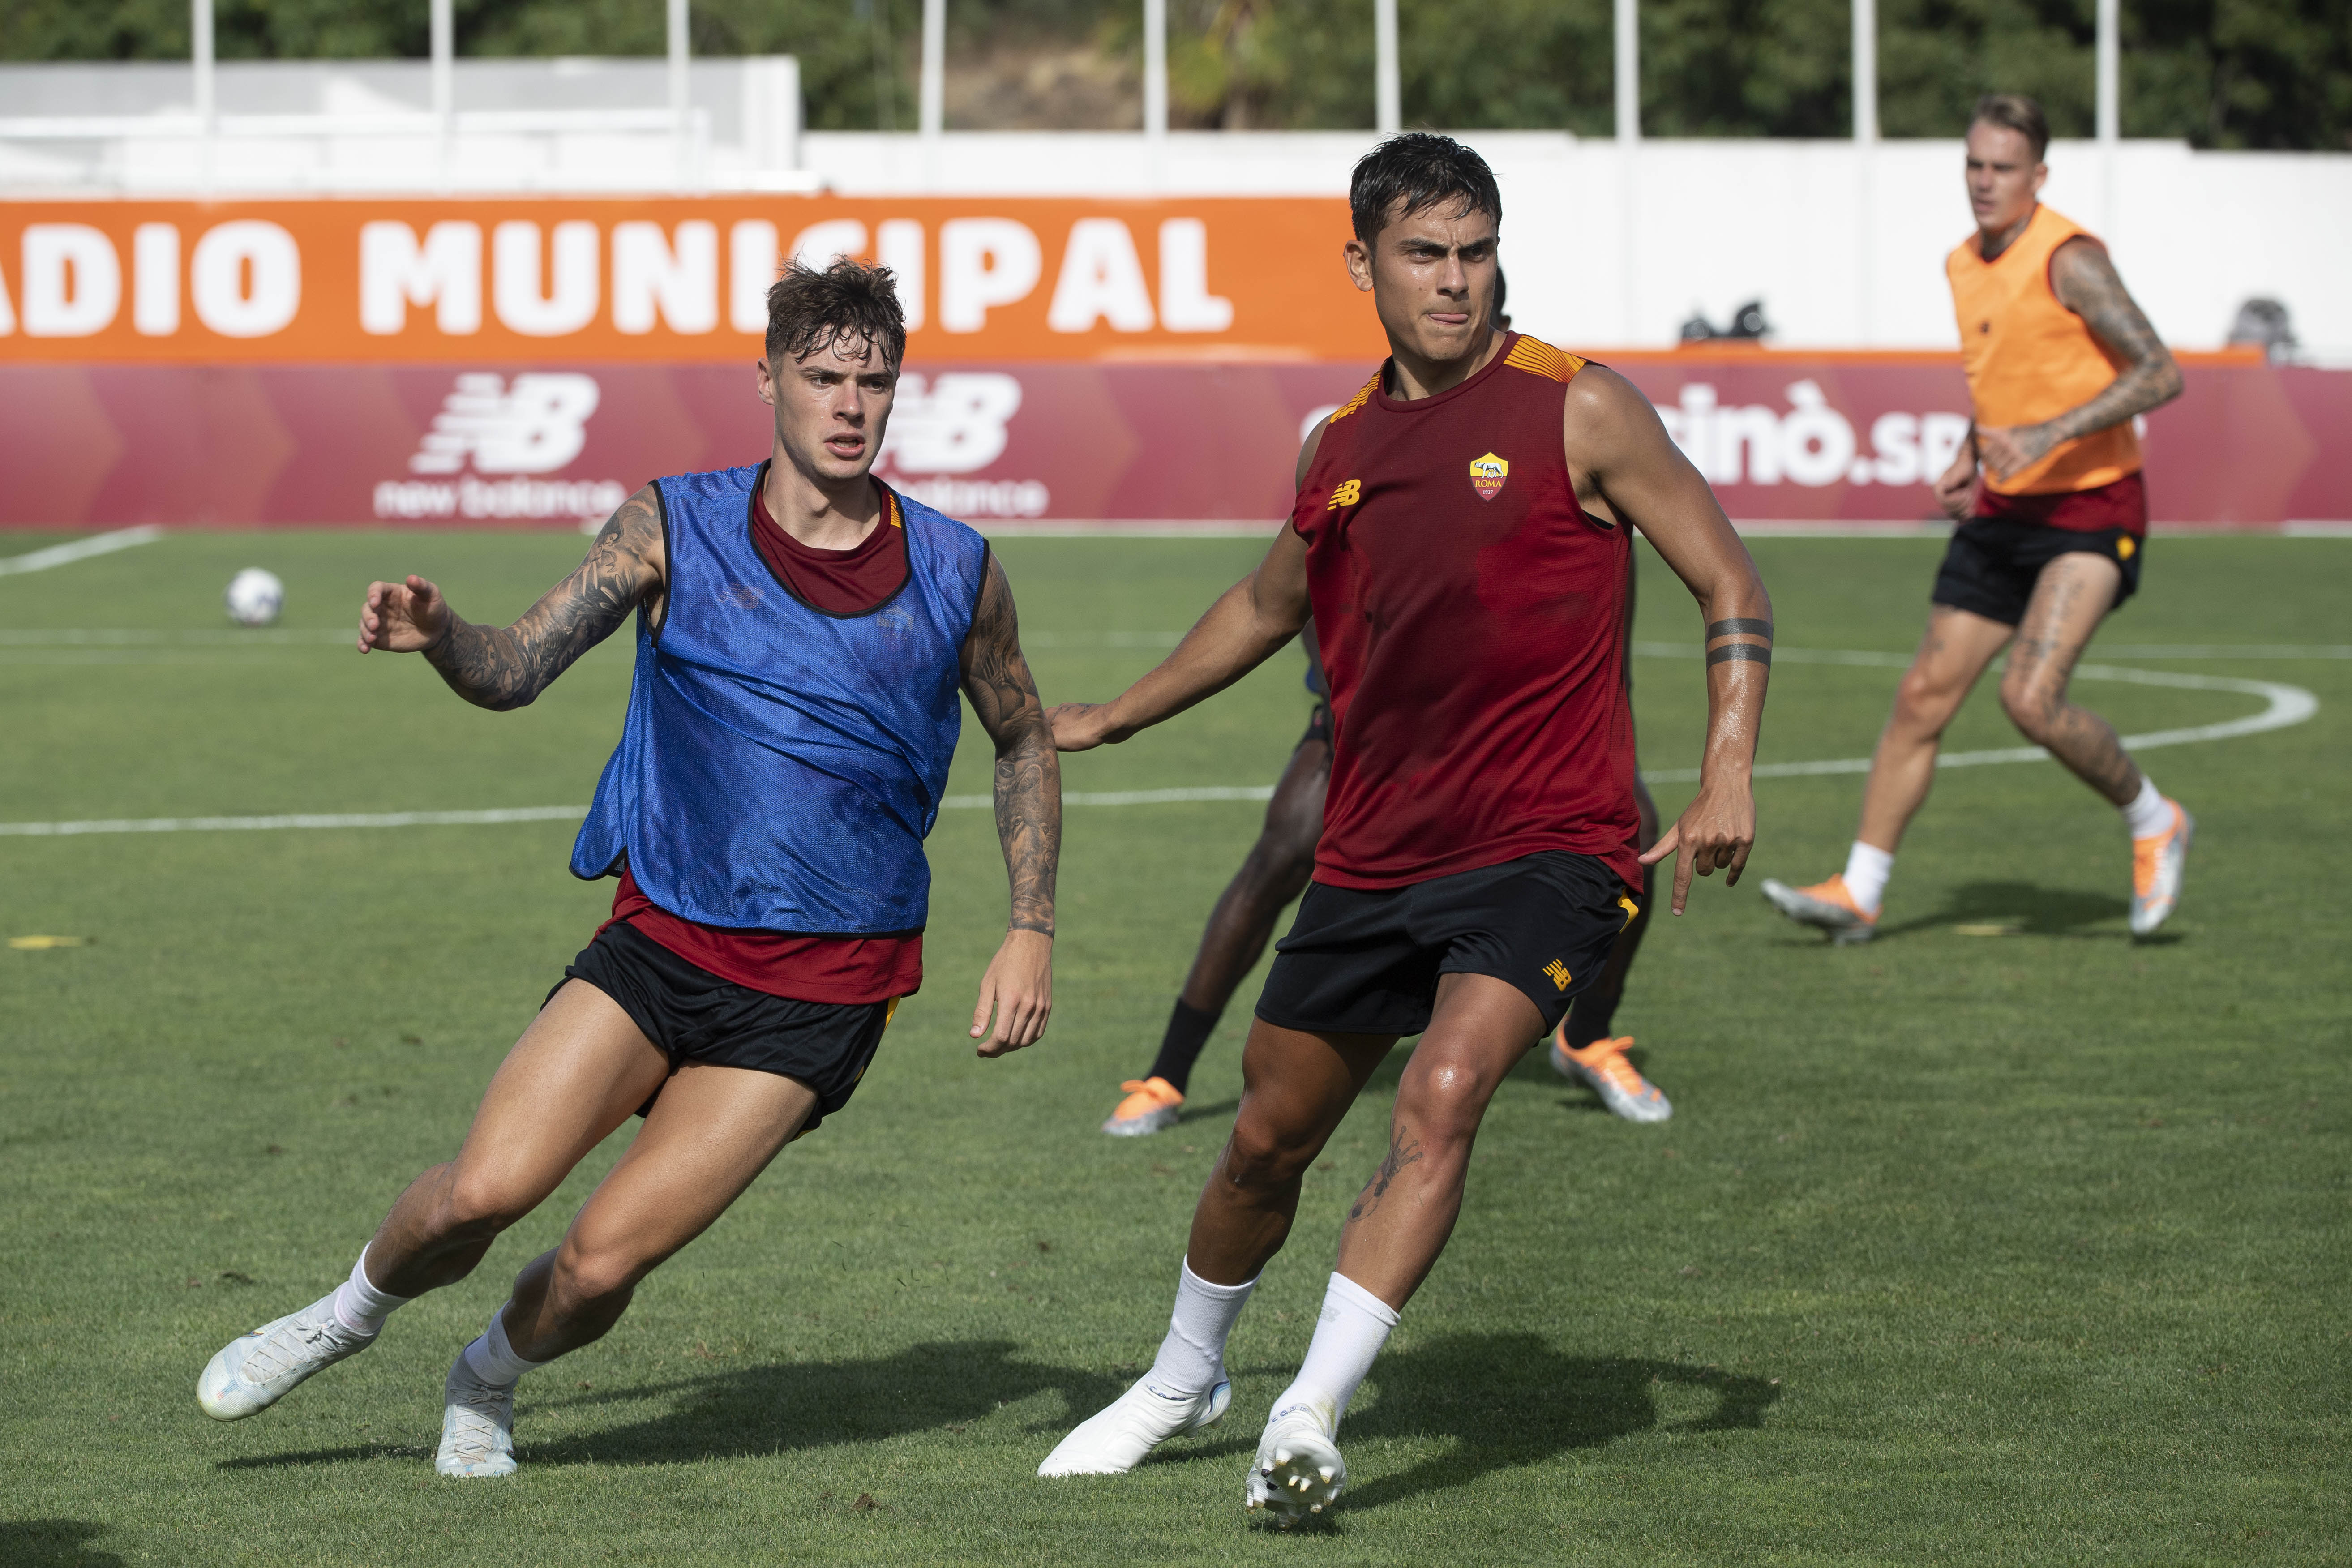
[0,195,1383,364]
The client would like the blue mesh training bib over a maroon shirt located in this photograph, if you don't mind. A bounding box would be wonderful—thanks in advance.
[571,463,988,936]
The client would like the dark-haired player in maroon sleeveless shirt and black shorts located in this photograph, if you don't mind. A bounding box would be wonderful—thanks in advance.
[1040,132,1771,1523]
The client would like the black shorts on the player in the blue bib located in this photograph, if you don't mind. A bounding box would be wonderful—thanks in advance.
[548,921,899,1135]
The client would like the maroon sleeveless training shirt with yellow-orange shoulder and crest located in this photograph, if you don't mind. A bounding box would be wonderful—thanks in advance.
[1291,334,1642,889]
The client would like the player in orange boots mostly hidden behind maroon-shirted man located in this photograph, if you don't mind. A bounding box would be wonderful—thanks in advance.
[1103,268,1675,1138]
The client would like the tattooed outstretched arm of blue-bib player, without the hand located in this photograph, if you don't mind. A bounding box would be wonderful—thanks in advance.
[426,489,661,712]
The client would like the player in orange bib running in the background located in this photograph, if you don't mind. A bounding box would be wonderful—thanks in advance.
[1764,94,2197,943]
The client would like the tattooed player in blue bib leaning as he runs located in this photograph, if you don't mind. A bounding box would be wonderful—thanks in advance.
[197,261,1061,1476]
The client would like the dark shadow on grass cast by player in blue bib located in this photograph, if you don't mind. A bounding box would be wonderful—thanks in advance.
[218,1340,1127,1476]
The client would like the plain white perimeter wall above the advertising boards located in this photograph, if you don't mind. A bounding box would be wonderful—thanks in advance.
[802,132,2352,362]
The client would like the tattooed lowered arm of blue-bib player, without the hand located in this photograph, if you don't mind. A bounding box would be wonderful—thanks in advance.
[964,555,1061,936]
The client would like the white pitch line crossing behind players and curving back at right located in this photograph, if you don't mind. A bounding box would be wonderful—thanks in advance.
[0,644,2319,839]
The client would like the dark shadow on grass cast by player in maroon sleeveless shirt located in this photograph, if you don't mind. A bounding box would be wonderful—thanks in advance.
[1341,1333,1781,1512]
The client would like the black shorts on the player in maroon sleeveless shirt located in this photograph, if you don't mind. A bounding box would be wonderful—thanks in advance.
[1258,851,1639,1034]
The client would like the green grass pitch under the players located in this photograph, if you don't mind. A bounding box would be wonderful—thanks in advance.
[0,534,2352,1568]
